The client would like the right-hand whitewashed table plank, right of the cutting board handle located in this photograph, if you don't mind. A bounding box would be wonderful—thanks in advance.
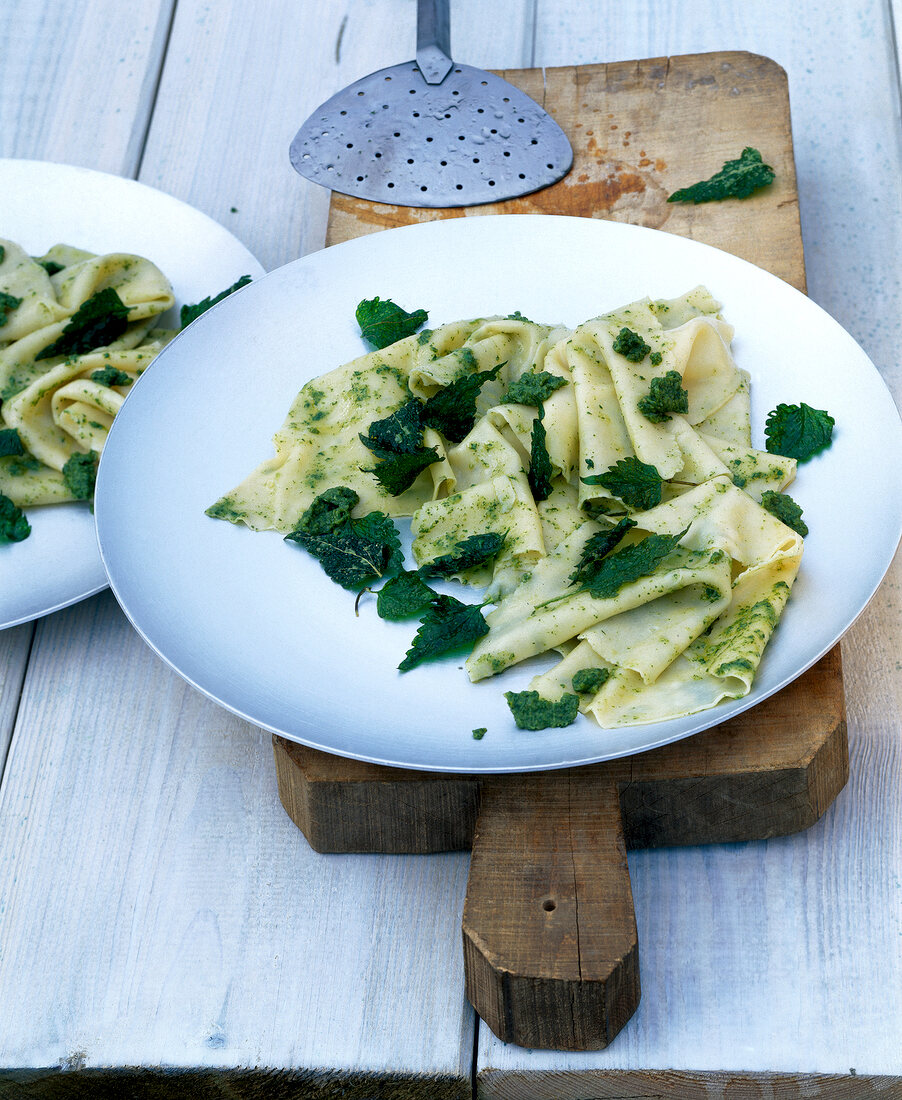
[477,0,902,1082]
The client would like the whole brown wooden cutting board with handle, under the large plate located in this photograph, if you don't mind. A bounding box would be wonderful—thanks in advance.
[273,53,848,1051]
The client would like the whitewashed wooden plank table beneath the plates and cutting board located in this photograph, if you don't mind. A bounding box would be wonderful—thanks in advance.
[0,0,902,1100]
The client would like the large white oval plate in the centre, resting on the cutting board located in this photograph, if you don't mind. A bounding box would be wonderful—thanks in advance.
[96,215,902,772]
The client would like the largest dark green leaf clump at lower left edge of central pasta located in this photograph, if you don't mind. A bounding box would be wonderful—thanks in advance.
[285,485,402,589]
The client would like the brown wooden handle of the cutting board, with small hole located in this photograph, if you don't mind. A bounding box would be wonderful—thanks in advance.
[463,769,639,1051]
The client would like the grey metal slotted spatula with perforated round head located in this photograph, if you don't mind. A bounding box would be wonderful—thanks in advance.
[290,0,573,207]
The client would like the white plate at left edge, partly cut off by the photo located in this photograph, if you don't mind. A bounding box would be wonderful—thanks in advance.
[0,160,263,629]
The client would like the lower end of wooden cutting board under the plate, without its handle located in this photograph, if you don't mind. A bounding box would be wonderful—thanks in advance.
[273,649,848,854]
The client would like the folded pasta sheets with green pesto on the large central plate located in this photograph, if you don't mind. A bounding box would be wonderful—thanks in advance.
[208,287,802,727]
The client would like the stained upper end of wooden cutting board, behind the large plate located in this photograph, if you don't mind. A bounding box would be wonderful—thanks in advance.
[327,53,804,289]
